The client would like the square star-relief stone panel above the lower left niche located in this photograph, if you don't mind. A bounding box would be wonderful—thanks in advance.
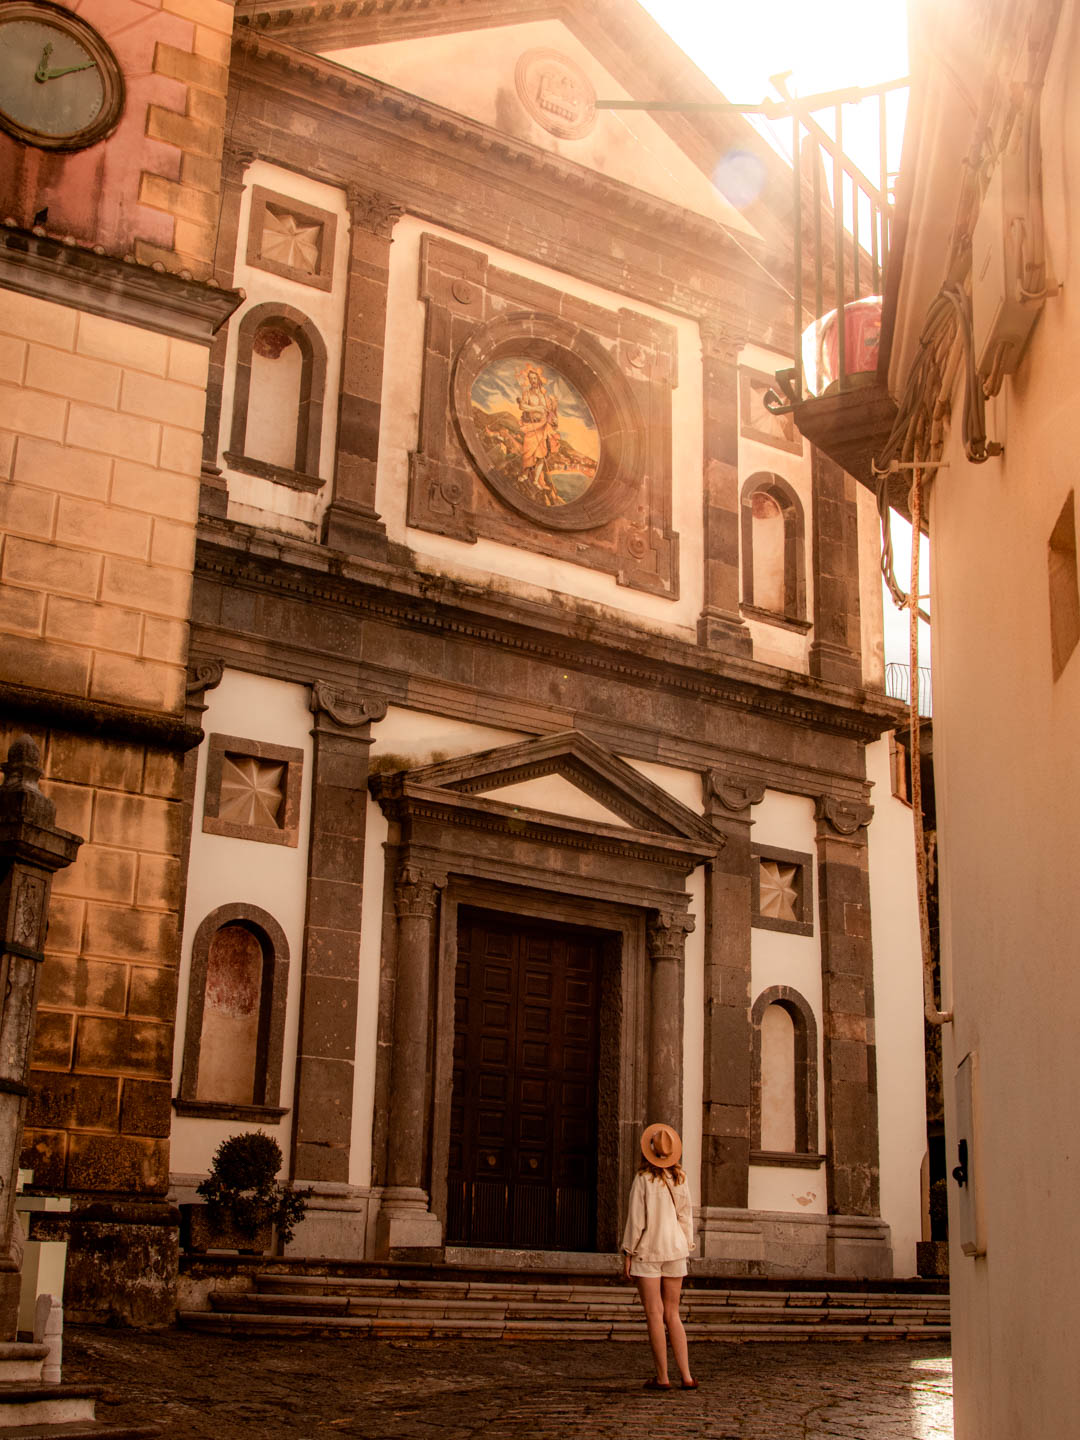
[203,734,304,847]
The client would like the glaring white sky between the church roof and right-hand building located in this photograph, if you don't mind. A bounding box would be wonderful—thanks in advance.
[641,0,930,665]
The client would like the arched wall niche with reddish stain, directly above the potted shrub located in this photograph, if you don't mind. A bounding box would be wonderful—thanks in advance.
[176,904,289,1120]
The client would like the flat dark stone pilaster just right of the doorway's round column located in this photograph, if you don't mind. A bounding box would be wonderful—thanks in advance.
[701,770,765,1232]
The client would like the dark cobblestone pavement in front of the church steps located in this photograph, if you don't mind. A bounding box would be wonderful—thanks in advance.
[63,1326,952,1440]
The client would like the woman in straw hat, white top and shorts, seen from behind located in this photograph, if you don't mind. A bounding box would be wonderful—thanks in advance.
[622,1125,697,1390]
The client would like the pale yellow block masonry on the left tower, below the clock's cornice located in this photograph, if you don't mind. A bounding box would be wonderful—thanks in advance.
[0,294,207,720]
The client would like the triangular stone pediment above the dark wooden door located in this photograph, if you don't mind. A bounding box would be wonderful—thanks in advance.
[370,730,723,868]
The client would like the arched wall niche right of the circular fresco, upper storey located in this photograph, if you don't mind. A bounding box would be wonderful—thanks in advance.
[742,472,806,621]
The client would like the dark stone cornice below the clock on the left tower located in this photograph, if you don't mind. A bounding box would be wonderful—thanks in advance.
[0,225,242,346]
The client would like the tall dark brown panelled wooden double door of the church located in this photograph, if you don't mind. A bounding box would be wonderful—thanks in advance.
[446,907,603,1250]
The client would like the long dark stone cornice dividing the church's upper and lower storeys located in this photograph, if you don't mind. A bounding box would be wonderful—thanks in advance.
[196,521,906,743]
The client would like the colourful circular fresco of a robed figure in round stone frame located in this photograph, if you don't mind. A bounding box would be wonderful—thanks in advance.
[469,354,600,508]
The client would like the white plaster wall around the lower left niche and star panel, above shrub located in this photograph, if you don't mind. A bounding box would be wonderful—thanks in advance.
[170,670,311,1175]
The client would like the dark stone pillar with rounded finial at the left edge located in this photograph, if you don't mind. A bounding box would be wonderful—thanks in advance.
[0,736,82,1342]
